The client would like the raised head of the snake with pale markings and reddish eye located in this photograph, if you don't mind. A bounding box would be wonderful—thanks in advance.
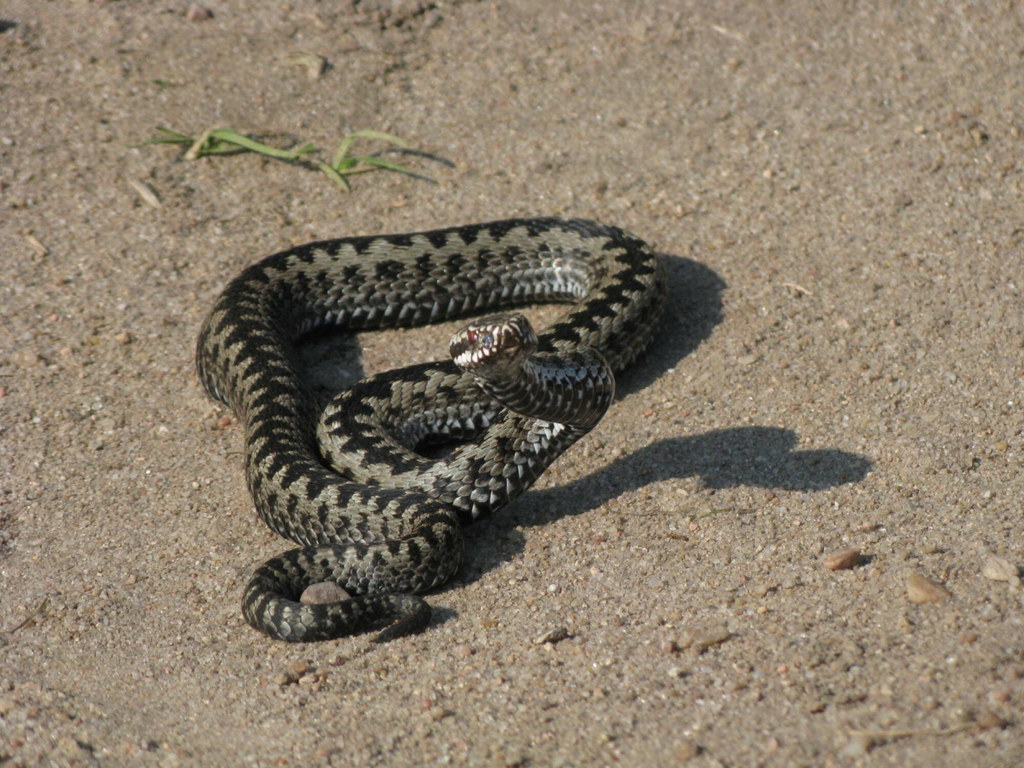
[449,312,538,376]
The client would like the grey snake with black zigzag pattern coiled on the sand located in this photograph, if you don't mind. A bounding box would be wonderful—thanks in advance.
[196,217,667,642]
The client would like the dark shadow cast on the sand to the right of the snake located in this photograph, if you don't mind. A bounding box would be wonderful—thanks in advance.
[439,254,872,581]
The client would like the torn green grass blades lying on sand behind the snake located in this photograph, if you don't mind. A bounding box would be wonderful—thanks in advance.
[136,126,444,191]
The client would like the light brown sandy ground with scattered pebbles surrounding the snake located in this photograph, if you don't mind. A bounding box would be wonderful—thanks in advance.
[0,0,1024,768]
